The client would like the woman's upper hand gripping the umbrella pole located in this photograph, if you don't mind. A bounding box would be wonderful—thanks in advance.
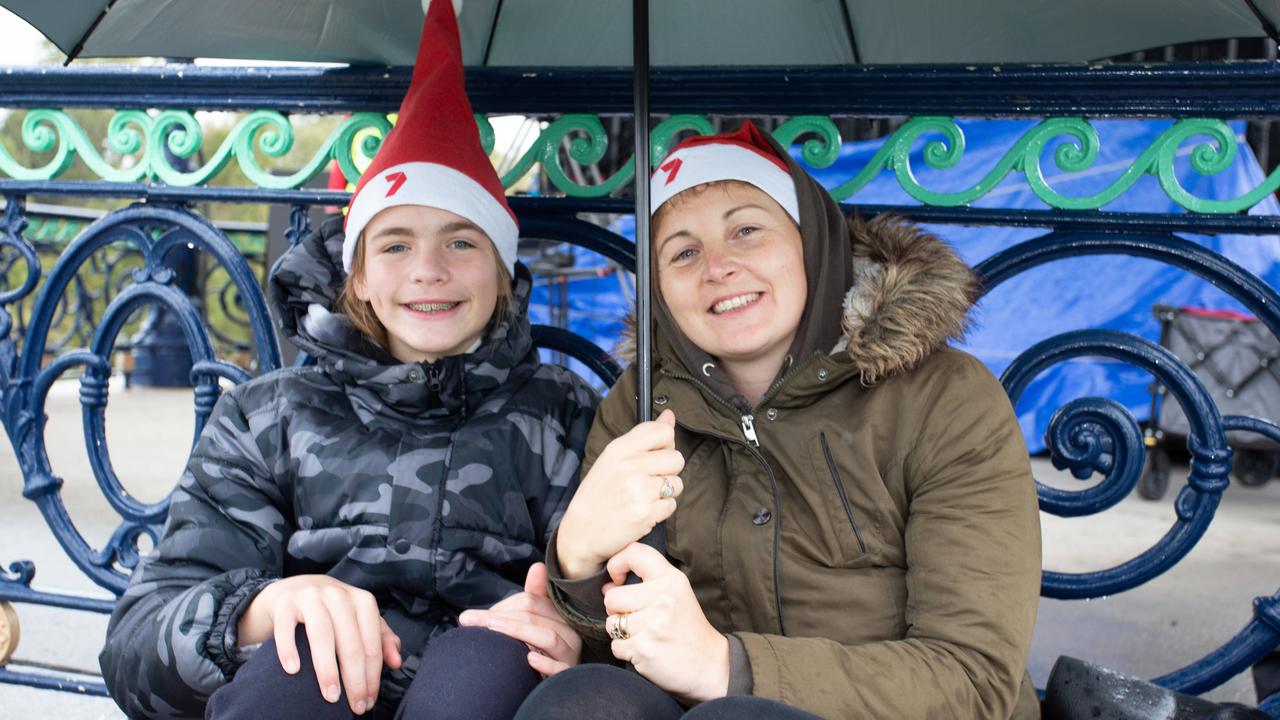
[556,410,685,579]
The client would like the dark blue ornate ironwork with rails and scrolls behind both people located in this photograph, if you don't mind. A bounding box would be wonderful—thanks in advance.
[0,64,1280,717]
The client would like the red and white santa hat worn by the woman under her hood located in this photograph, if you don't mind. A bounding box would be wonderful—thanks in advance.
[649,120,800,224]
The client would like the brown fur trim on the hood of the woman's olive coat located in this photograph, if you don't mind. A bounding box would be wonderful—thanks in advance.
[629,214,980,386]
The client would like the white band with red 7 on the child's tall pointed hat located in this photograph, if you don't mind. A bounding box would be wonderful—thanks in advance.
[342,163,520,275]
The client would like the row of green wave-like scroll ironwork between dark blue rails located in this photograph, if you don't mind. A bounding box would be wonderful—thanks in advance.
[0,109,1280,214]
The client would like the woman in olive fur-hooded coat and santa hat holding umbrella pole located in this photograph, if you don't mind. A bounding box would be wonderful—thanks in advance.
[488,123,1041,720]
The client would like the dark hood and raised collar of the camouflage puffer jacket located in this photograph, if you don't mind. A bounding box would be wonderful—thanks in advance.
[270,217,536,424]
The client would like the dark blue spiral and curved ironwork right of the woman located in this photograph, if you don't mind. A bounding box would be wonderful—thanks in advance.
[977,231,1280,693]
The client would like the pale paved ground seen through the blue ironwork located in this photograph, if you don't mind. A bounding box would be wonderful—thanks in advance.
[0,382,1280,720]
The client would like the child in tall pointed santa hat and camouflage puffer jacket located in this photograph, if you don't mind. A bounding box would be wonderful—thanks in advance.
[101,3,596,720]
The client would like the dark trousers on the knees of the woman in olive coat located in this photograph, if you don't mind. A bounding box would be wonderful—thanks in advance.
[516,665,819,720]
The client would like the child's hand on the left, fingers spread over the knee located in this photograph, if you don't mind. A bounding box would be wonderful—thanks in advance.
[237,575,402,715]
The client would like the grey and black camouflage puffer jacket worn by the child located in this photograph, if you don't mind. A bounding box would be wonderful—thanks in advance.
[100,218,598,717]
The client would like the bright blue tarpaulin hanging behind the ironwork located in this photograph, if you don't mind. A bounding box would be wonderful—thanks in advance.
[535,120,1280,451]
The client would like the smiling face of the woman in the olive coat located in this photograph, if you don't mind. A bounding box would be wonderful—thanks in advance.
[654,181,806,378]
